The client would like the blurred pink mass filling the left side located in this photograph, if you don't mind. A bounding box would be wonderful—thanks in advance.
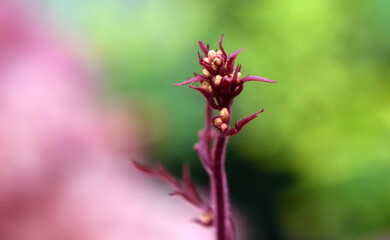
[0,1,213,240]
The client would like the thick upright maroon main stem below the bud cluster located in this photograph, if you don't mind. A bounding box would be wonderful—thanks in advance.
[210,107,233,240]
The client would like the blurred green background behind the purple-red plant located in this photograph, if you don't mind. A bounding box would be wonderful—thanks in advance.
[45,0,390,240]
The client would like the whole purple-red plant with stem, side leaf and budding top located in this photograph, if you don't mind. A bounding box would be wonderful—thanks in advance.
[135,35,275,240]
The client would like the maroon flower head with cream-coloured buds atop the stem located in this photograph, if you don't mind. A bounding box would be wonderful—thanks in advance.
[175,35,275,132]
